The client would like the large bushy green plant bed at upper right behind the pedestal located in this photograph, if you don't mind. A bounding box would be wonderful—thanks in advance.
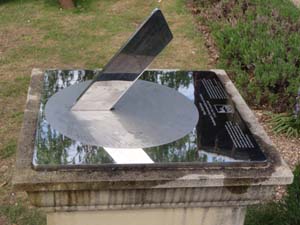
[195,0,300,112]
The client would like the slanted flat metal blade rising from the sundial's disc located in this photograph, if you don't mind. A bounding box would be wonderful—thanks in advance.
[72,9,173,111]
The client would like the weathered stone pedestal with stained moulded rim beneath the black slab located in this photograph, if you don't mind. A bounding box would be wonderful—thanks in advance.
[13,69,293,225]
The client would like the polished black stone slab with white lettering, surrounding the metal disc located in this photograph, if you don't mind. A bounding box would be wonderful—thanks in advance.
[33,70,266,169]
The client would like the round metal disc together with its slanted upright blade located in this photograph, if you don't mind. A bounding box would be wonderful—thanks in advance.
[46,9,198,148]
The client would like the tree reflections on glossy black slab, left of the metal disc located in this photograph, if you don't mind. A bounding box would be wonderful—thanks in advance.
[34,70,112,165]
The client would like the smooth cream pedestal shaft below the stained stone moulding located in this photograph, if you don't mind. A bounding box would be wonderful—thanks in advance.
[47,207,246,225]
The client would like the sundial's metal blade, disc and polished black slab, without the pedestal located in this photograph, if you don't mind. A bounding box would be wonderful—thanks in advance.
[33,9,266,169]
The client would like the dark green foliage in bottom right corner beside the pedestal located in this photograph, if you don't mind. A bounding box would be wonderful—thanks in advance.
[245,165,300,225]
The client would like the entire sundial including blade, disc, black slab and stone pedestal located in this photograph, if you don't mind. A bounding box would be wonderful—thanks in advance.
[13,9,293,225]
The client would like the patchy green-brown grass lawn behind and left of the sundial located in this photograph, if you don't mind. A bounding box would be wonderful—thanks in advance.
[0,0,208,225]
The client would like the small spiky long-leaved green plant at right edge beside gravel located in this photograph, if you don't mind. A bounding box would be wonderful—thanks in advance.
[270,114,300,137]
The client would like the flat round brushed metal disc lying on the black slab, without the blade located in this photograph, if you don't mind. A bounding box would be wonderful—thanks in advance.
[45,80,199,148]
